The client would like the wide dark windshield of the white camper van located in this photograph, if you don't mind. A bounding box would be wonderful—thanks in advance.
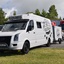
[2,21,27,31]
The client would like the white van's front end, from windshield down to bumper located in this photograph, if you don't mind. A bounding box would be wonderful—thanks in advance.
[0,20,28,50]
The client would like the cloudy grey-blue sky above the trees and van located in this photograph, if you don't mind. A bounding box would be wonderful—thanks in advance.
[0,0,64,17]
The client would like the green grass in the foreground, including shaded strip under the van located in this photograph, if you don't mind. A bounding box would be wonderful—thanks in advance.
[0,48,64,64]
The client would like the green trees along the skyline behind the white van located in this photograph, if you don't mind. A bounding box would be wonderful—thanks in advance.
[0,5,64,24]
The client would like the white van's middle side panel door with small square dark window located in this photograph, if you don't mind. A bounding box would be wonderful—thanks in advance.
[36,22,46,45]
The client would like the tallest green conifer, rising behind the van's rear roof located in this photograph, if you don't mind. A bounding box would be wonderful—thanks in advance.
[48,5,58,19]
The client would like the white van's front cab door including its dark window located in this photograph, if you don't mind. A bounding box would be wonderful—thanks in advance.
[27,20,36,47]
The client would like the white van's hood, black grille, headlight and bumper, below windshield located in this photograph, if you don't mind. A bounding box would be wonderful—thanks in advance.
[0,31,24,50]
